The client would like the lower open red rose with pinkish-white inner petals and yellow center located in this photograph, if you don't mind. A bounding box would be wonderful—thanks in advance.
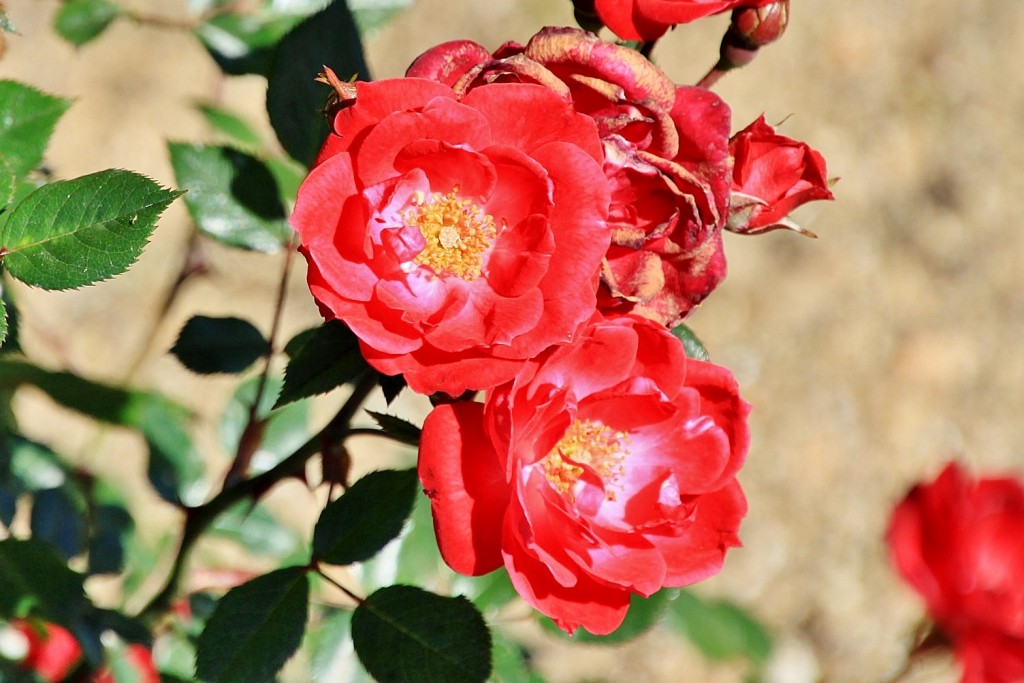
[419,316,750,634]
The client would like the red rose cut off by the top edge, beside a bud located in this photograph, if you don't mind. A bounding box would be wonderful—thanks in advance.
[575,0,775,40]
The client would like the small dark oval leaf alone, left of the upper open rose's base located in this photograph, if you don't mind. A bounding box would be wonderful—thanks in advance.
[171,315,270,375]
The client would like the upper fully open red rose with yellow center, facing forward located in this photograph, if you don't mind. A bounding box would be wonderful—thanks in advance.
[292,78,609,395]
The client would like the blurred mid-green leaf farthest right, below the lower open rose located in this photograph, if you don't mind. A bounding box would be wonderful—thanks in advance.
[669,590,772,664]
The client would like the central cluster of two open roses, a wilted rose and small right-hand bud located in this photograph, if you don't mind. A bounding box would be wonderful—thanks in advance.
[292,25,831,634]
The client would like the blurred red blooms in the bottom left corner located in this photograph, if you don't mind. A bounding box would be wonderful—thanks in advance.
[10,620,160,683]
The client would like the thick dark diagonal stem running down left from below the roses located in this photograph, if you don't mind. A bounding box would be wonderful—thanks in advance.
[139,374,377,620]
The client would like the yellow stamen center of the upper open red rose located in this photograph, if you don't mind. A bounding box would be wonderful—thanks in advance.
[404,187,497,282]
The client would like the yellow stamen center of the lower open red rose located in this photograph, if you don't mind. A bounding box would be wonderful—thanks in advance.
[541,420,629,501]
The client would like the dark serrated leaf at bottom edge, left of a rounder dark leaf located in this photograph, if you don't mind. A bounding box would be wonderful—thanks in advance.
[196,567,309,683]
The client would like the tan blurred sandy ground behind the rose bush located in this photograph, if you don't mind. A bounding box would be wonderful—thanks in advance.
[0,0,1024,683]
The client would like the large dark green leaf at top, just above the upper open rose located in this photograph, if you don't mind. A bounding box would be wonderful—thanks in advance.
[266,0,370,167]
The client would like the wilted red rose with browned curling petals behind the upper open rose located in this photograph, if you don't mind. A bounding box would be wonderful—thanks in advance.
[408,28,730,327]
